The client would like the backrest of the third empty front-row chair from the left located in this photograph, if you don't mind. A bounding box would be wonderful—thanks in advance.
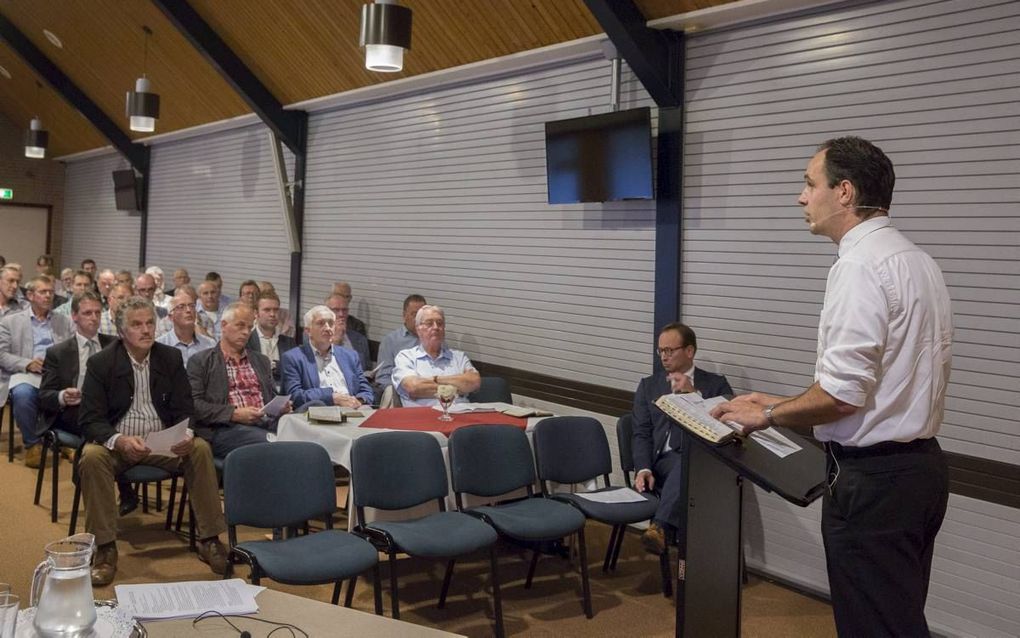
[448,425,534,496]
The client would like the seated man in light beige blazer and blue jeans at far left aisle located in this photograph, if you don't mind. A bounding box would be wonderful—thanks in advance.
[0,275,71,468]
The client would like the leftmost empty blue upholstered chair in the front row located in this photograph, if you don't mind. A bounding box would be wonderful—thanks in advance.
[223,441,381,614]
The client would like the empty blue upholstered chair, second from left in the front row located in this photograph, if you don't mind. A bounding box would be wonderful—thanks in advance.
[351,432,504,637]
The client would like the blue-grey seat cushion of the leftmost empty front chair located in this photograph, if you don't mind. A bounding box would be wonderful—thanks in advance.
[238,530,378,585]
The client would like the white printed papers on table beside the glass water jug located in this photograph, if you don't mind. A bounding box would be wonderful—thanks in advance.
[113,578,265,621]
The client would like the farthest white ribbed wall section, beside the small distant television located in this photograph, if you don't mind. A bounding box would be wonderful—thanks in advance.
[61,152,141,271]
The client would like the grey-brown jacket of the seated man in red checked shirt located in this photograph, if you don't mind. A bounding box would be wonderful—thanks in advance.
[188,344,276,438]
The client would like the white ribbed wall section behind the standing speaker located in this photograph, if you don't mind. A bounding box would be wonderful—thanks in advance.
[681,0,1020,636]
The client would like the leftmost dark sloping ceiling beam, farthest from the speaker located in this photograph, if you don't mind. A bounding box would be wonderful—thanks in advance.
[0,13,149,176]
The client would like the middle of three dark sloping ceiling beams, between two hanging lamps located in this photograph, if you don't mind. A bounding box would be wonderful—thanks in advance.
[152,0,308,155]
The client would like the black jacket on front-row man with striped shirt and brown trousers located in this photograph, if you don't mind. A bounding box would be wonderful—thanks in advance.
[79,341,195,443]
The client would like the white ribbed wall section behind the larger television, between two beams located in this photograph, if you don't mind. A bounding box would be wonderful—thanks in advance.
[302,59,655,390]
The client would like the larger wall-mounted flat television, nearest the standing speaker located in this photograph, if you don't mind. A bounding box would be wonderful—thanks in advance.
[546,106,654,204]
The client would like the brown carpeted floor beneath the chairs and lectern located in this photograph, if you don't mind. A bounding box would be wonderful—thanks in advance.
[0,424,835,638]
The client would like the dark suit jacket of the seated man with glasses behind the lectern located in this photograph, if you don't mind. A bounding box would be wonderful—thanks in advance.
[631,366,733,470]
